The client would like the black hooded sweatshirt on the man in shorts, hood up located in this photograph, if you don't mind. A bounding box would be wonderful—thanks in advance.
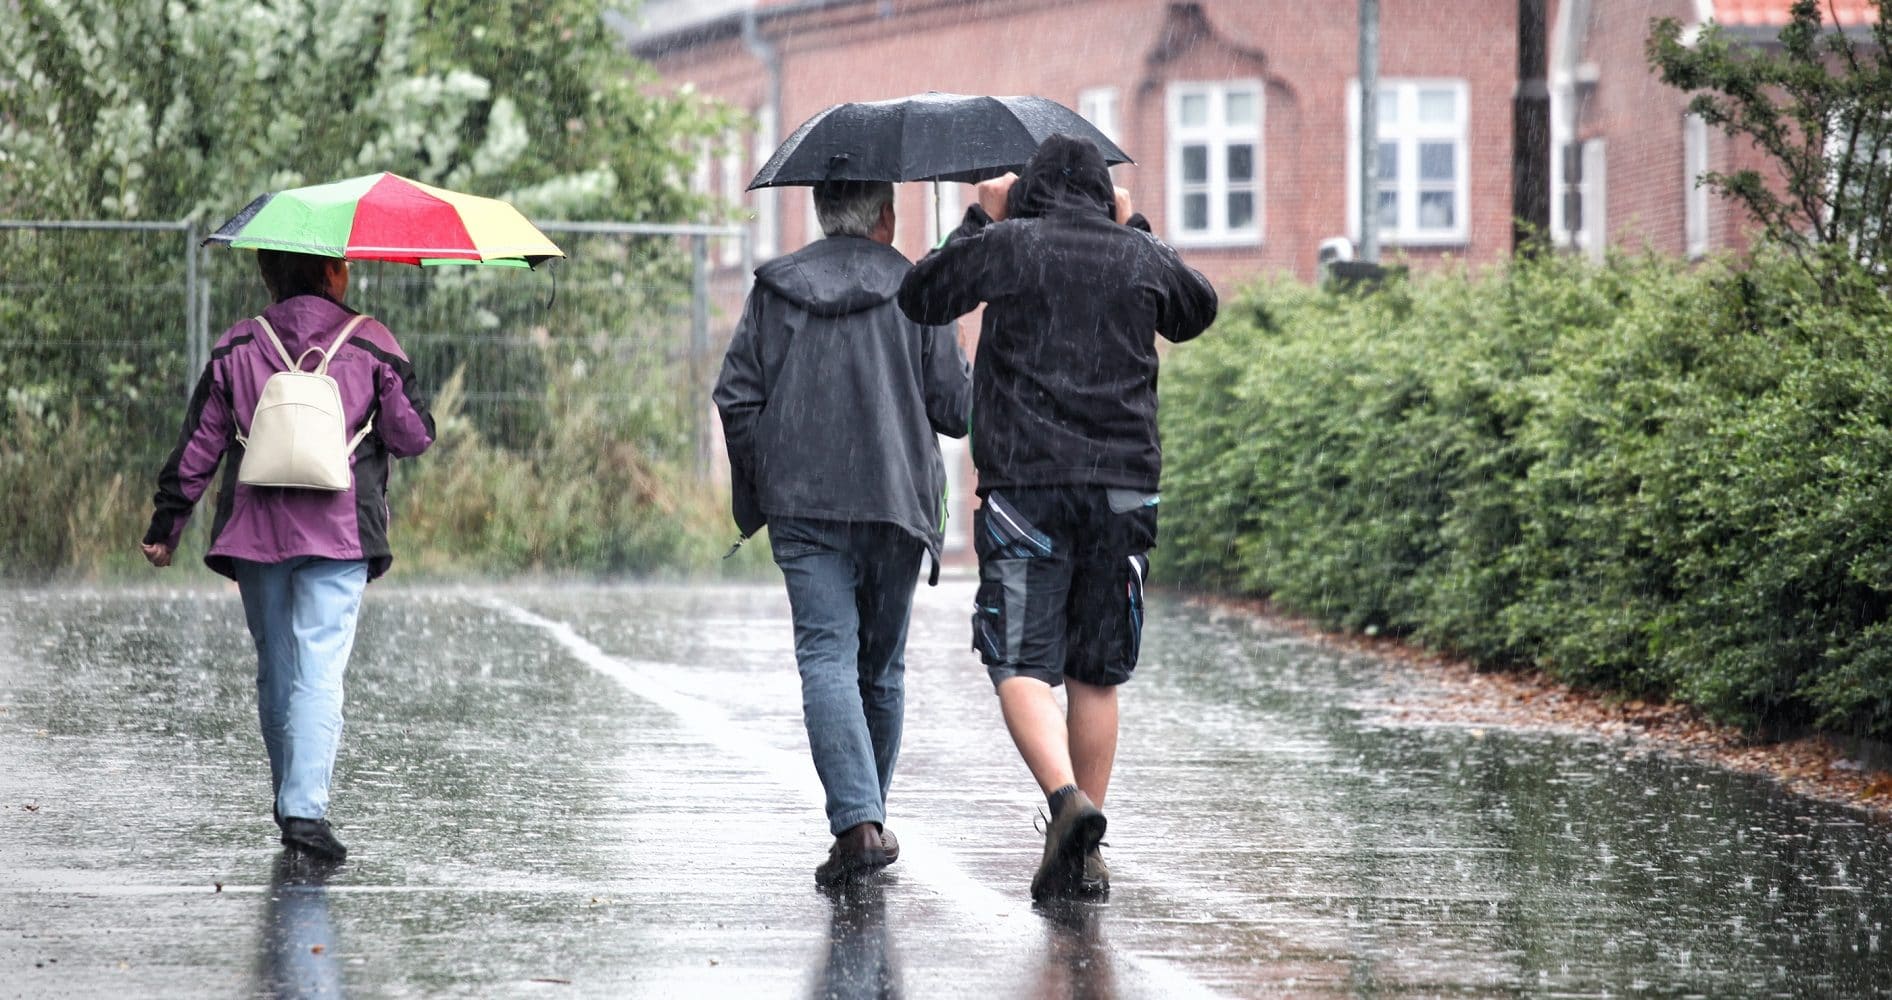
[899,136,1217,495]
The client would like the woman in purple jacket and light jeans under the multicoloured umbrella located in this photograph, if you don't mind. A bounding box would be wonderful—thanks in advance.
[144,250,433,862]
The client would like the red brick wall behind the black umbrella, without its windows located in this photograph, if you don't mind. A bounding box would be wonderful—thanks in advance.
[655,0,1515,289]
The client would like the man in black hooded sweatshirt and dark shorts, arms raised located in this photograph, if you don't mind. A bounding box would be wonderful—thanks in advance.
[899,136,1217,900]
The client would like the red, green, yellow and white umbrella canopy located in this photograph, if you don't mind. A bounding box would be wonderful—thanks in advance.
[204,174,566,267]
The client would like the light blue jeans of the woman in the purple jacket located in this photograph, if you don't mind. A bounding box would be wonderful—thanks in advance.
[237,556,367,819]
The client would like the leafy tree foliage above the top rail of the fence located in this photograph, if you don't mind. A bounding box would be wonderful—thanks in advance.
[0,0,728,225]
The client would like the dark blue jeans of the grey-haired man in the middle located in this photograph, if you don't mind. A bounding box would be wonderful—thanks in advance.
[768,518,925,836]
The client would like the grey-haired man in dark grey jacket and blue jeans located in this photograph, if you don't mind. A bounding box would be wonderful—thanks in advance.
[715,181,971,885]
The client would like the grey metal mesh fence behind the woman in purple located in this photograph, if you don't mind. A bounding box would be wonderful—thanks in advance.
[0,221,751,565]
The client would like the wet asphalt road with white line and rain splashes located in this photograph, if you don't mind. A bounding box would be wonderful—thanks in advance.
[0,578,1892,1000]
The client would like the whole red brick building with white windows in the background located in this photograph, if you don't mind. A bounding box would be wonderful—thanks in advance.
[628,0,1871,289]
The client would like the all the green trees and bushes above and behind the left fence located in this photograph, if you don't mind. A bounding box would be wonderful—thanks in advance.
[0,0,753,575]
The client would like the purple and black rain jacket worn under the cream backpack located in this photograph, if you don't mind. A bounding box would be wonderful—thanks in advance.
[144,295,433,578]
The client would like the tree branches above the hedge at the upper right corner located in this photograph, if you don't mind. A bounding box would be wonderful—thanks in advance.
[1648,0,1892,291]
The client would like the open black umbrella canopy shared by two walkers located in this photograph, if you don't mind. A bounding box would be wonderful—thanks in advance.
[749,91,1135,191]
